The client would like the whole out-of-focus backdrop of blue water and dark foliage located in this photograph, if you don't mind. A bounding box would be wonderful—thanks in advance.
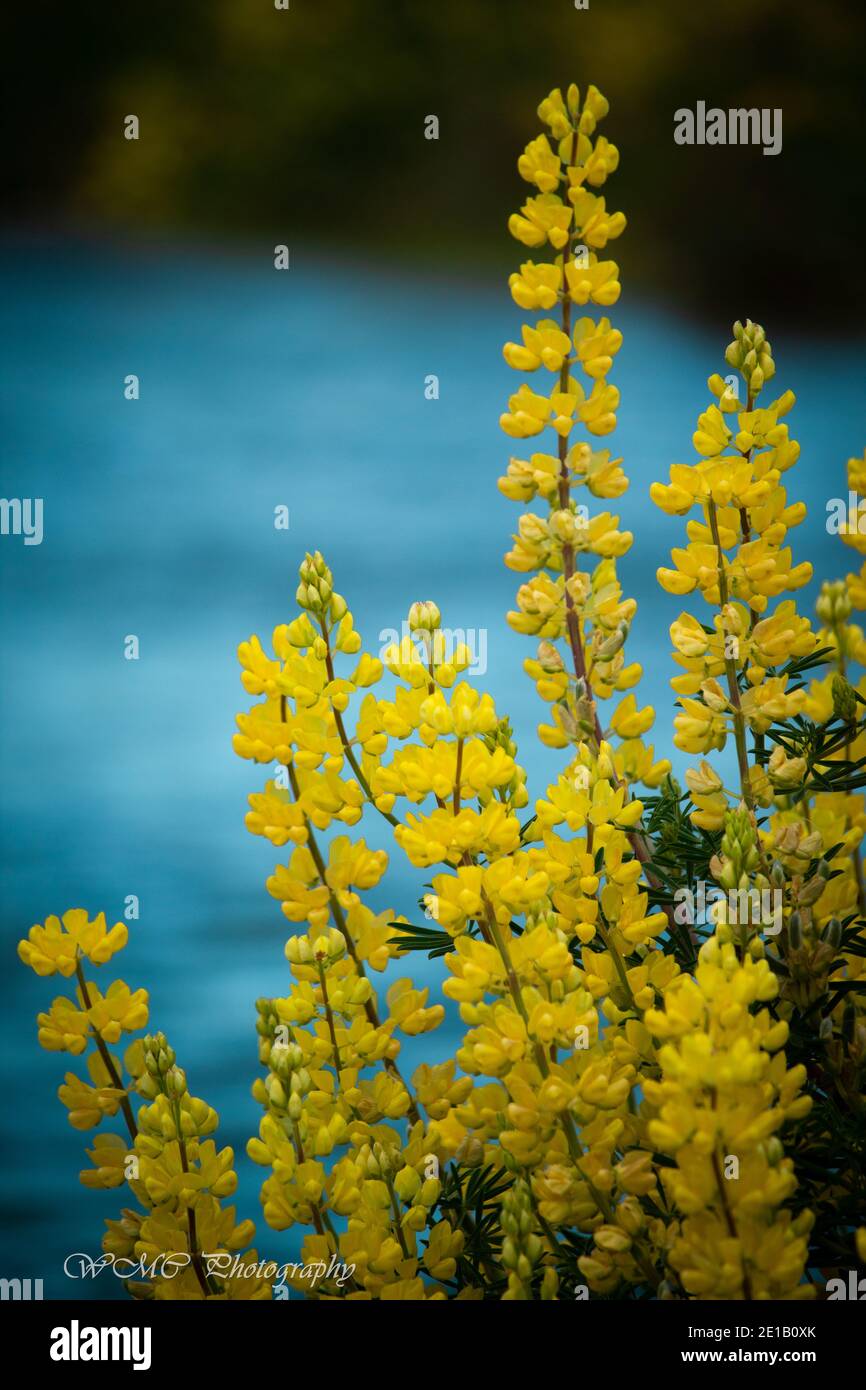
[0,0,866,1298]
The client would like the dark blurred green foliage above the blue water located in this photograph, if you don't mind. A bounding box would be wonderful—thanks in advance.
[3,0,866,328]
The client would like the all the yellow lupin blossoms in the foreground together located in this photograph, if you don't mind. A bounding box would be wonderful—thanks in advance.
[22,86,866,1301]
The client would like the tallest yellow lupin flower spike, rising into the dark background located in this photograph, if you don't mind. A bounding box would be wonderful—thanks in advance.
[499,86,670,787]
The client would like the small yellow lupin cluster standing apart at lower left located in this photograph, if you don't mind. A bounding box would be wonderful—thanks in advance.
[18,908,271,1301]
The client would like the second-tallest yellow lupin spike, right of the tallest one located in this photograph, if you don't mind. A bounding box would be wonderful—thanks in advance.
[651,320,817,811]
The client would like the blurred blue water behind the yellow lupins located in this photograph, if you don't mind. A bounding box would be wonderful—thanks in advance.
[0,239,866,1298]
